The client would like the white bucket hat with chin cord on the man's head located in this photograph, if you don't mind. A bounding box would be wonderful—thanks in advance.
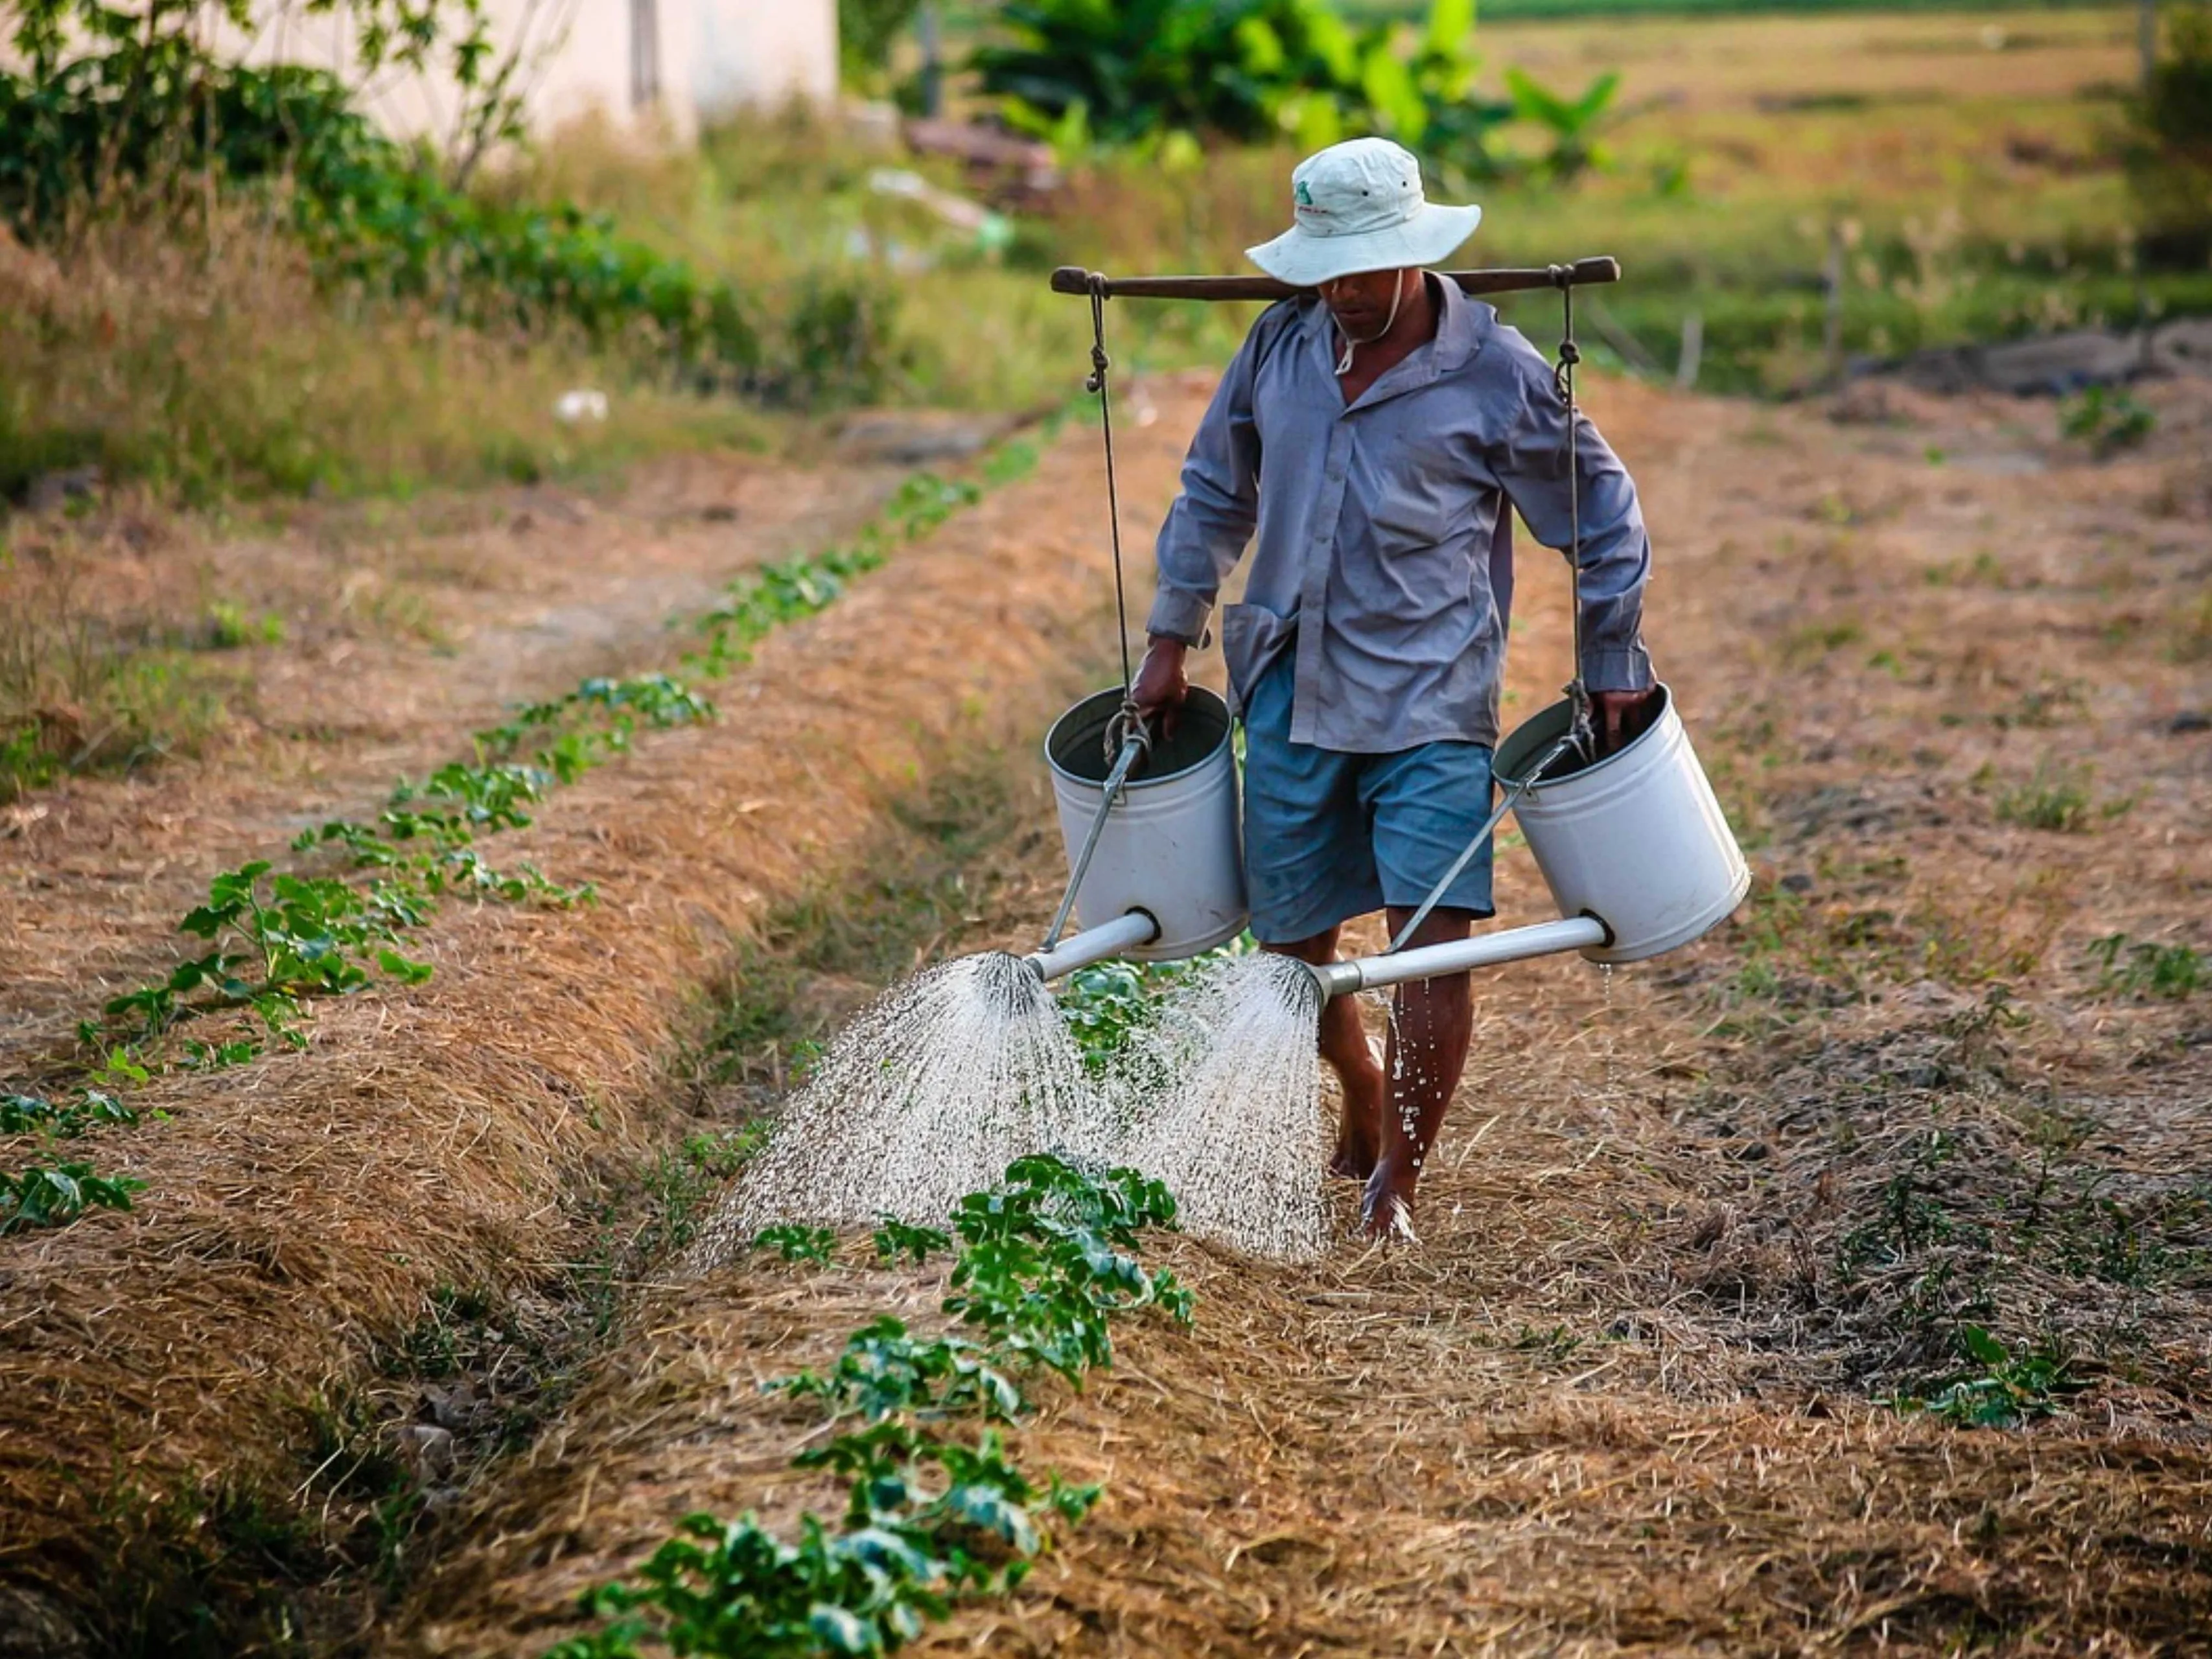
[1246,139,1482,288]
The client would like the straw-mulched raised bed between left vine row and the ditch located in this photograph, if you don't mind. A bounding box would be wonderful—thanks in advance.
[0,391,1194,1636]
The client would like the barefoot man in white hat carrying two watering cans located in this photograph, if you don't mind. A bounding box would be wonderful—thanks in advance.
[1135,137,1659,1238]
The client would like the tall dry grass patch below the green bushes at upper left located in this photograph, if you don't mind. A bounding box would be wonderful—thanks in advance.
[0,213,759,511]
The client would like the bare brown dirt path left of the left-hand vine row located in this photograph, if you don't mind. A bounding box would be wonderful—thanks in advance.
[0,456,900,1077]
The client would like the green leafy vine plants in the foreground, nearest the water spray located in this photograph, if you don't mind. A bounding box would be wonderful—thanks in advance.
[544,1157,1193,1659]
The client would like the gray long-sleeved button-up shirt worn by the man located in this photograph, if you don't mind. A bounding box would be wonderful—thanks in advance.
[1146,277,1650,754]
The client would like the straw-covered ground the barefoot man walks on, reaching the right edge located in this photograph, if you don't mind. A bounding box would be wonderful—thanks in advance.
[390,385,2212,1657]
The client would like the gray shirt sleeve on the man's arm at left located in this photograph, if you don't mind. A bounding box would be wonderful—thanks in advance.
[1144,316,1274,644]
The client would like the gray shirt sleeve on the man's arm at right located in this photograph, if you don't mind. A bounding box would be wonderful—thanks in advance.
[1491,327,1653,690]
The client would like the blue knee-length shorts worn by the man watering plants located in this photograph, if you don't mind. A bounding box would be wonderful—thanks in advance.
[1243,653,1491,944]
